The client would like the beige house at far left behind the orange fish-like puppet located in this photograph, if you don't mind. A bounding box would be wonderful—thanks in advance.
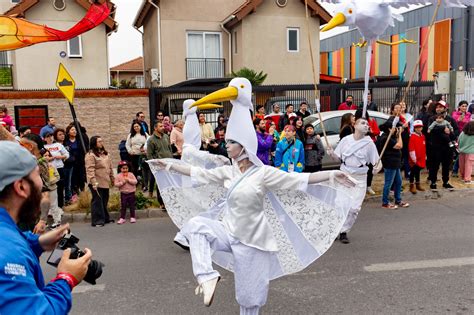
[0,0,117,90]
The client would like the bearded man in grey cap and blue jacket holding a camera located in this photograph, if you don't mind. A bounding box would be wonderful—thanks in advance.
[0,141,92,314]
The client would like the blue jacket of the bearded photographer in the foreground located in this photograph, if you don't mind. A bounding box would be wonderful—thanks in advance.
[0,208,72,315]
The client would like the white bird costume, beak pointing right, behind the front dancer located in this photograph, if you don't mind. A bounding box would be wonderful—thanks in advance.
[181,99,230,169]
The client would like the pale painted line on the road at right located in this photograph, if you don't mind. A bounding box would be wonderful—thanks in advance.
[364,257,474,272]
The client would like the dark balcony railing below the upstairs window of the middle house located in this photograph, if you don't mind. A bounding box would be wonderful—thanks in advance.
[185,58,225,80]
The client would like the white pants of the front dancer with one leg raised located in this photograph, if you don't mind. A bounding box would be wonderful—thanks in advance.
[181,216,271,315]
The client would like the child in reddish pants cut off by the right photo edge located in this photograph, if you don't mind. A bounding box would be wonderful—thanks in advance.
[458,121,474,184]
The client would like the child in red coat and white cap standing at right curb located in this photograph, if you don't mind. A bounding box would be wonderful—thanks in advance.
[408,120,426,194]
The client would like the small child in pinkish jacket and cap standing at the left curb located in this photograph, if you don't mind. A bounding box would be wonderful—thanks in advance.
[114,161,137,224]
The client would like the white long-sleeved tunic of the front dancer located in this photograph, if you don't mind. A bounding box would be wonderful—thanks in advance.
[191,166,309,251]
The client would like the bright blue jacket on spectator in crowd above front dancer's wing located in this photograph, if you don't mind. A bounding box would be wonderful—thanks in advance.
[275,138,304,173]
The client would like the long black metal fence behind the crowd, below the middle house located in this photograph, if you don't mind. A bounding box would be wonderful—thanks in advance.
[150,81,434,126]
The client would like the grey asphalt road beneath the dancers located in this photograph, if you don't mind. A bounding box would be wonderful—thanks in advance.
[42,191,474,314]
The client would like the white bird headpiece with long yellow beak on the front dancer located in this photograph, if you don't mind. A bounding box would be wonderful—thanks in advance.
[192,78,263,166]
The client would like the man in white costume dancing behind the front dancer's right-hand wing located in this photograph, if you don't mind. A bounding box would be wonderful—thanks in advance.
[329,118,380,244]
